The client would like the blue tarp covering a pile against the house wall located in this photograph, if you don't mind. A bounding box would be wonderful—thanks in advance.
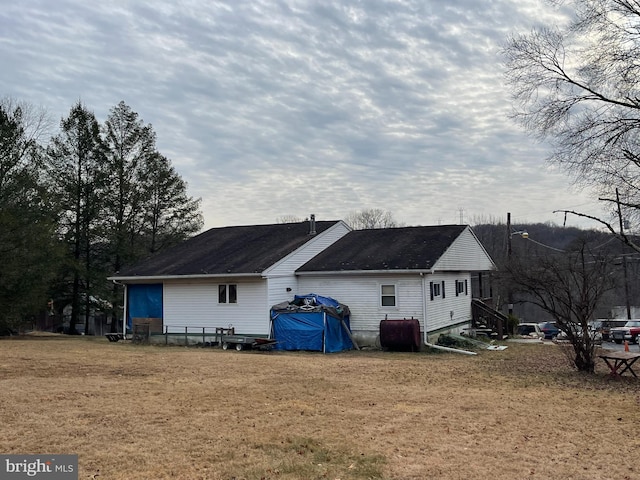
[271,293,353,353]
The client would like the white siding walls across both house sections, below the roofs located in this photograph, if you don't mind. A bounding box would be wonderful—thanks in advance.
[163,273,471,342]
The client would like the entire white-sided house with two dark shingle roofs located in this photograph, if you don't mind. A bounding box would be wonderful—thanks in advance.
[111,216,495,344]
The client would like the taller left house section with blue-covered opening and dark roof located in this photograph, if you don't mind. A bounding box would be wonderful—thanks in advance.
[110,216,351,335]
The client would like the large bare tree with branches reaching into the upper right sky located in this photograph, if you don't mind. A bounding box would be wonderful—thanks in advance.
[504,0,640,251]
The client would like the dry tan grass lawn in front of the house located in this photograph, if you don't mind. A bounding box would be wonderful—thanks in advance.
[0,336,640,480]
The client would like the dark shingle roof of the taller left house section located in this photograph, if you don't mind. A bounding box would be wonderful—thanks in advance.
[114,221,338,278]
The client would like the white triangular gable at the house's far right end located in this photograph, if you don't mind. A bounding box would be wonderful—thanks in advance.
[435,228,495,272]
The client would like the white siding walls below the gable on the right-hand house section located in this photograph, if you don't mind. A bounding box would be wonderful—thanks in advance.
[298,272,471,335]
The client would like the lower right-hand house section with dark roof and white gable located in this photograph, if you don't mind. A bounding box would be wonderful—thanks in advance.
[296,225,495,343]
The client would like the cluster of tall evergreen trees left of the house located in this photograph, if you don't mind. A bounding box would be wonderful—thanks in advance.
[0,99,203,333]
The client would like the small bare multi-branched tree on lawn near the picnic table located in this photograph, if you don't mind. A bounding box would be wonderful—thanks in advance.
[502,240,615,373]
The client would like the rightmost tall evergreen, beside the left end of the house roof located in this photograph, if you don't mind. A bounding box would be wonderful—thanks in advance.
[102,102,203,330]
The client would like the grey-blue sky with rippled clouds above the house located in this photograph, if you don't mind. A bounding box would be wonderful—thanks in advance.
[0,0,602,228]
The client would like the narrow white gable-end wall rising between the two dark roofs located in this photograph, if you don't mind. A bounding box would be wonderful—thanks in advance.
[263,221,351,308]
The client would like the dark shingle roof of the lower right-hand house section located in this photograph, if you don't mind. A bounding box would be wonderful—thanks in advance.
[297,225,467,272]
